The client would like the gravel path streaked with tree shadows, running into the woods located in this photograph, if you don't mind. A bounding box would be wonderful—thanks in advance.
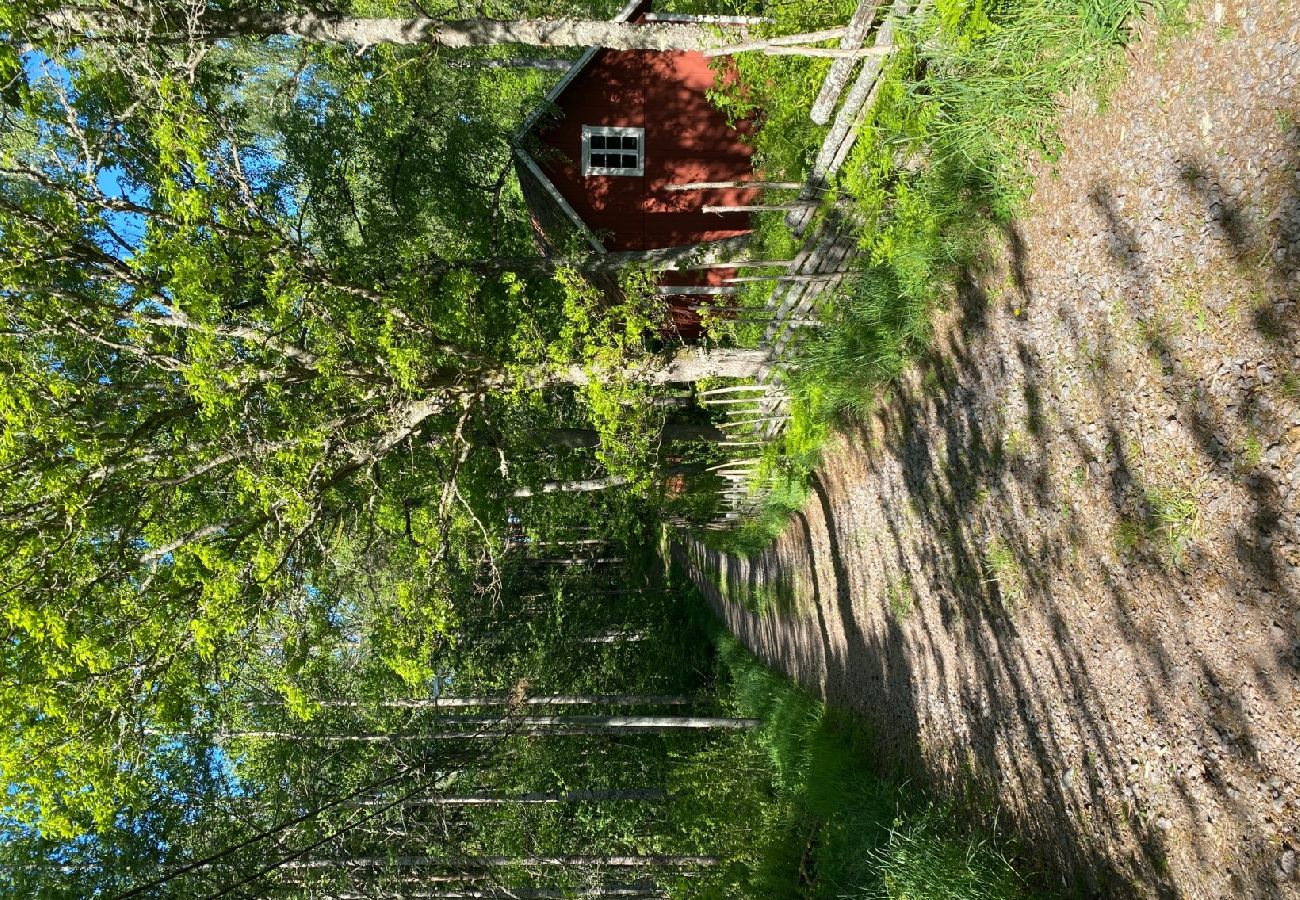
[686,1,1300,897]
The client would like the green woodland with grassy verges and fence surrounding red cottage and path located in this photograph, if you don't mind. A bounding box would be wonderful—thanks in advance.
[0,0,1284,900]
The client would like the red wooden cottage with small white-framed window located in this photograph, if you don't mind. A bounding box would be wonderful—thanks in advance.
[515,0,755,341]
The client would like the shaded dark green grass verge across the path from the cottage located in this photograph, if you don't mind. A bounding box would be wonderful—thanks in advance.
[703,637,1028,900]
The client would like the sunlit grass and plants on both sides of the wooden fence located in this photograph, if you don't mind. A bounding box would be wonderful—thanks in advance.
[702,0,1183,544]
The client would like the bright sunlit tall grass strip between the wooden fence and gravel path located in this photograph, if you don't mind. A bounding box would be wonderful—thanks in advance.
[797,0,1164,415]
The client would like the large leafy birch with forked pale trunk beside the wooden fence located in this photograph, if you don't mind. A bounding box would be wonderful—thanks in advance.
[0,17,766,836]
